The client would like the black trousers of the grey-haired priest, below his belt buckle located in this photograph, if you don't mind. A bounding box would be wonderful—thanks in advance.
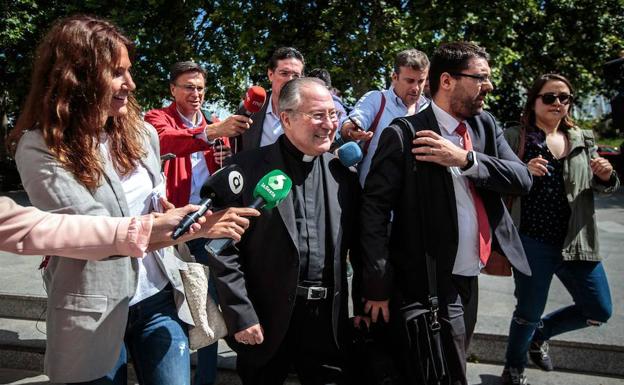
[236,297,350,385]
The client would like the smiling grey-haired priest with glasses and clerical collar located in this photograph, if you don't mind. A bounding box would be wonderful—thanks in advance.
[210,78,361,385]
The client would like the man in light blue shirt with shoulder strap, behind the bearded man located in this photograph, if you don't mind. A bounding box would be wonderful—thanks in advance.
[336,49,429,186]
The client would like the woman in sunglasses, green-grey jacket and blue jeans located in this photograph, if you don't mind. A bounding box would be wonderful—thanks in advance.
[502,74,619,384]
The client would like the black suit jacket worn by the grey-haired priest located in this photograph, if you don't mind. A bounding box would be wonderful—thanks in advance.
[210,136,361,366]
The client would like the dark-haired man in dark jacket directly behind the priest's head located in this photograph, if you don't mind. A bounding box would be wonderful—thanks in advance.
[232,47,305,152]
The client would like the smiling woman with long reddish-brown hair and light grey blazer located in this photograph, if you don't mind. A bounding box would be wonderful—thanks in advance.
[10,16,259,385]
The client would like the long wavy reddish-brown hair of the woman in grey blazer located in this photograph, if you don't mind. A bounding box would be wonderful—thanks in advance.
[8,15,145,190]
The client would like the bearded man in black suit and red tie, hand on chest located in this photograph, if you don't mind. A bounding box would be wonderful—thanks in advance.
[361,42,532,384]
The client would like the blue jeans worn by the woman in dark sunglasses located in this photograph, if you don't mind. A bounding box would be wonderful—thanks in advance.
[505,235,612,368]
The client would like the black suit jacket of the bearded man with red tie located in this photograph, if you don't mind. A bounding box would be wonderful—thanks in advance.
[361,106,532,300]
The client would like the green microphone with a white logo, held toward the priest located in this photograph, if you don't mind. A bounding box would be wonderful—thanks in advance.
[206,170,292,257]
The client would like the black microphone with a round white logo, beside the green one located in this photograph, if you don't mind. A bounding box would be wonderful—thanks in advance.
[171,164,243,239]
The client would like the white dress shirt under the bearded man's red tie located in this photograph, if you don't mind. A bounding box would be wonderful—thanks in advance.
[431,102,483,277]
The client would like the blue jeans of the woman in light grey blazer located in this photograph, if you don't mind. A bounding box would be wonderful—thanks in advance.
[73,286,191,385]
